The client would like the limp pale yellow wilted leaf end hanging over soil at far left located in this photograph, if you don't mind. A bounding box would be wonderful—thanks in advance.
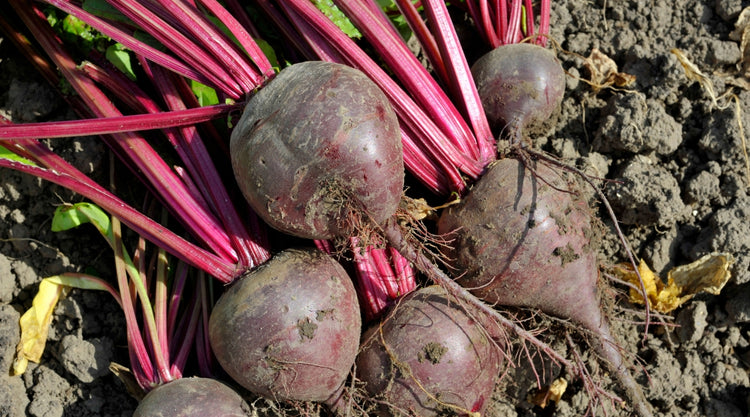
[12,278,70,375]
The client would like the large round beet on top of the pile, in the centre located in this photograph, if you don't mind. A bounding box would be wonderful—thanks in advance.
[230,61,404,239]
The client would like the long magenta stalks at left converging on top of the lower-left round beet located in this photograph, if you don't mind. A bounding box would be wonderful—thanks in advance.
[0,1,270,282]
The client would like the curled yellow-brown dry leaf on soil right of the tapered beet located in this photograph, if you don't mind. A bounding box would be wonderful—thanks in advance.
[615,253,734,313]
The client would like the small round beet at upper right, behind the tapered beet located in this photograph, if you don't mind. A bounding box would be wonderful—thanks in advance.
[471,43,565,139]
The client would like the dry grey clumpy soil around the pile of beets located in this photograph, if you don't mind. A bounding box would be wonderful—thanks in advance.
[0,0,750,417]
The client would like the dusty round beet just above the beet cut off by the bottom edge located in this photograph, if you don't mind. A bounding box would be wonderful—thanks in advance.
[209,249,362,401]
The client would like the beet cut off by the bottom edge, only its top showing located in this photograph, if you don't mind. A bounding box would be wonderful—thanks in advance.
[133,378,251,417]
